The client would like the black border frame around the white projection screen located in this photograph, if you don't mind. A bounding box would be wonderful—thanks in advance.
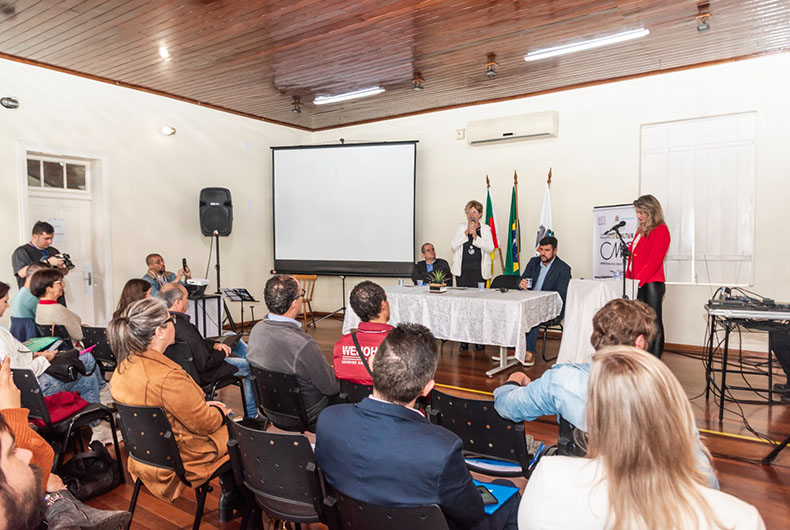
[270,140,419,278]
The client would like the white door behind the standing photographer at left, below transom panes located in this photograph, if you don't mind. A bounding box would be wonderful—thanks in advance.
[28,194,96,325]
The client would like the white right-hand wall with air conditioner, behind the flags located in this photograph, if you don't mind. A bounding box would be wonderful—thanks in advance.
[313,54,790,344]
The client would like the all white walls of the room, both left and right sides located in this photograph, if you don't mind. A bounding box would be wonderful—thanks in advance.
[0,54,790,344]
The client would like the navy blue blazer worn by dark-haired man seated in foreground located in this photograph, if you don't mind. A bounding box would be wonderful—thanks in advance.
[315,398,484,529]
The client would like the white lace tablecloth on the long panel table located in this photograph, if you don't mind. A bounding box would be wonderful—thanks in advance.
[343,286,562,361]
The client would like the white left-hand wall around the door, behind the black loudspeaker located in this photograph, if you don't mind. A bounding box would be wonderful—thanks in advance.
[0,60,310,324]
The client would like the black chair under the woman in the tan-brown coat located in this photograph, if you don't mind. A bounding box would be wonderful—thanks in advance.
[115,402,222,530]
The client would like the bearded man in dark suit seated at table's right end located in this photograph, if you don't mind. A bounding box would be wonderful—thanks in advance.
[518,236,571,366]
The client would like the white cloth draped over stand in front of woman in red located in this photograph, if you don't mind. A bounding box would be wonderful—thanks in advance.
[557,280,636,364]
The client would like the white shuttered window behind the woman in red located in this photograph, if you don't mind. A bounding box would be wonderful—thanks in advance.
[641,112,757,285]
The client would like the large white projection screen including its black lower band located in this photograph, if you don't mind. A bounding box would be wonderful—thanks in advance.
[272,141,417,276]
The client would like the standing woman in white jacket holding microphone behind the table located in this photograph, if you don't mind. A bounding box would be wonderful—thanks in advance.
[451,201,494,351]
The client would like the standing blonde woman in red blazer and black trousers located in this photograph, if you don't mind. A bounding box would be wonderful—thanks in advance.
[626,195,669,359]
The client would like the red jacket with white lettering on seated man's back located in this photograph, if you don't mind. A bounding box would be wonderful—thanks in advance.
[332,322,392,385]
